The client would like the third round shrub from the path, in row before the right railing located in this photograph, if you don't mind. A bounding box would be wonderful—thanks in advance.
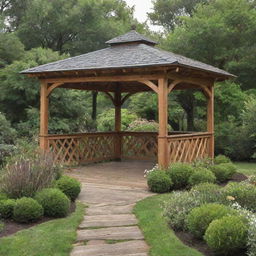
[188,168,216,186]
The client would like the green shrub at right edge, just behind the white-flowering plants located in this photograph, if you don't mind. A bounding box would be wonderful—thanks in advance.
[223,182,256,212]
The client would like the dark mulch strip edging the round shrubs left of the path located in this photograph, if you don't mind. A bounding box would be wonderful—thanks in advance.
[0,202,76,238]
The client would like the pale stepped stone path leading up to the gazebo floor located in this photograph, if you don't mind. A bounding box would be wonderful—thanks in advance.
[70,163,152,256]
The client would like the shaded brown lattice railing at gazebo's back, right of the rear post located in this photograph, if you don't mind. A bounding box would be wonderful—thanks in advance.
[121,132,157,160]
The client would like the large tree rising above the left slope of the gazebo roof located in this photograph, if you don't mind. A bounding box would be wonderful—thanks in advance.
[14,0,134,55]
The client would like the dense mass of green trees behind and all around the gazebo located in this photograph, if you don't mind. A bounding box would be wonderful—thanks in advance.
[0,0,256,160]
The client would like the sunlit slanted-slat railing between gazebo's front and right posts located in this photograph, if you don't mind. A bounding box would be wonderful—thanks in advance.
[167,133,213,163]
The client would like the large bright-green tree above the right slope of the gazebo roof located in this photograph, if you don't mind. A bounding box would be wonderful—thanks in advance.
[165,0,256,89]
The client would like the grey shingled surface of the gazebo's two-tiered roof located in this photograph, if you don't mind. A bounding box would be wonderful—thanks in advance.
[21,30,233,77]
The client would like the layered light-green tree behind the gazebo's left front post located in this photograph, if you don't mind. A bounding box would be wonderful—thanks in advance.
[0,48,94,135]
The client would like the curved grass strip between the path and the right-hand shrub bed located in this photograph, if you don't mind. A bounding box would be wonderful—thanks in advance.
[134,194,203,256]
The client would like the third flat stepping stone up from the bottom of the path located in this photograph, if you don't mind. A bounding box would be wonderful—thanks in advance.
[79,214,138,228]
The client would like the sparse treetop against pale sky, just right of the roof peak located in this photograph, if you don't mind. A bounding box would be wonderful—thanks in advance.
[148,0,210,31]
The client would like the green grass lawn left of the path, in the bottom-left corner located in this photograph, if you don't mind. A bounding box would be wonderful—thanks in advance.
[0,203,84,256]
